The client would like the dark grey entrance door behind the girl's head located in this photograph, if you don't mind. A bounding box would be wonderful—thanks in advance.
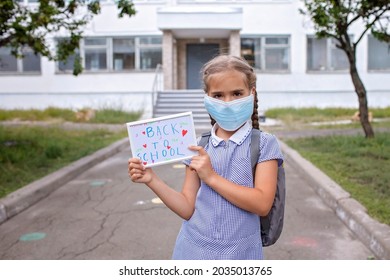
[187,44,219,89]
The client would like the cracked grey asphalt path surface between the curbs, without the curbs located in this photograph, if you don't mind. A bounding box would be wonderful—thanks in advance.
[0,139,372,260]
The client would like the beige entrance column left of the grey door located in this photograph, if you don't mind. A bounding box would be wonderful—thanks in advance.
[162,30,174,90]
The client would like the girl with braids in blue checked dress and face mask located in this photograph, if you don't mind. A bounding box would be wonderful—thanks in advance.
[128,55,283,259]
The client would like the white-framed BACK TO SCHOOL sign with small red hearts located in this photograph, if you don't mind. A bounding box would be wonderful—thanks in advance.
[126,112,197,167]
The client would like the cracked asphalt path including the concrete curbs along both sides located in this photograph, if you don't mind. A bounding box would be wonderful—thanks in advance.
[0,123,390,259]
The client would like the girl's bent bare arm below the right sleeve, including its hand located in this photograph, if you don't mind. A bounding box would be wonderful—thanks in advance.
[190,146,278,216]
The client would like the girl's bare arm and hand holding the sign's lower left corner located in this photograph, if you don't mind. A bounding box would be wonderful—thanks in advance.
[128,158,200,220]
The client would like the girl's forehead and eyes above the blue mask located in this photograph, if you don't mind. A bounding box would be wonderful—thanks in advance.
[207,70,252,102]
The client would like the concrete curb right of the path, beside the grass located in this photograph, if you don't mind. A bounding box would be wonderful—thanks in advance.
[279,140,390,260]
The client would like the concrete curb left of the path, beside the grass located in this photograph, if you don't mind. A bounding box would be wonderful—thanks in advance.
[0,137,129,224]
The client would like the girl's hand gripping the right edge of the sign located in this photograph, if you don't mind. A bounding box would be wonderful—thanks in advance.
[189,146,215,183]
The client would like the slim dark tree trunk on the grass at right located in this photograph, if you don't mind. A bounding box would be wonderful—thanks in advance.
[347,51,374,138]
